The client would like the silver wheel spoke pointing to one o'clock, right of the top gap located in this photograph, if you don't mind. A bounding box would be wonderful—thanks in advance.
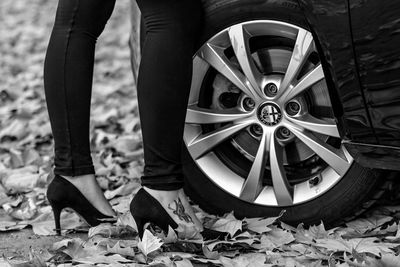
[280,29,313,92]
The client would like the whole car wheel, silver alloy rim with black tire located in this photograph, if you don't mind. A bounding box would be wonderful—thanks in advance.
[183,0,386,225]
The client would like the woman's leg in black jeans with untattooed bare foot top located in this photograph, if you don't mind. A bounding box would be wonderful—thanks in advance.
[44,0,115,215]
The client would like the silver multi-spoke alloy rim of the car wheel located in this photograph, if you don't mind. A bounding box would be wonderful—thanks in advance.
[184,20,353,206]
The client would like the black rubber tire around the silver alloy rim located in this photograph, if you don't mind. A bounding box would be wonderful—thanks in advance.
[183,0,388,226]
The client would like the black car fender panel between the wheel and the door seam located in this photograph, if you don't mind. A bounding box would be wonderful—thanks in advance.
[299,0,377,144]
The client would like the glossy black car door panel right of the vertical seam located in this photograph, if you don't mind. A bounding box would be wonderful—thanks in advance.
[349,0,400,148]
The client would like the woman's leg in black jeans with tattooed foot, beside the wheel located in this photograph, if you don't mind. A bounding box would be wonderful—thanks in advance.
[137,0,202,230]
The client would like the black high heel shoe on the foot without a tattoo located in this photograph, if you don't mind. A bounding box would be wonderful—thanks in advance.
[47,175,116,235]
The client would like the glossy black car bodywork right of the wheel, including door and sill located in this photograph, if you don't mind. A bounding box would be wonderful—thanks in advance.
[298,0,400,170]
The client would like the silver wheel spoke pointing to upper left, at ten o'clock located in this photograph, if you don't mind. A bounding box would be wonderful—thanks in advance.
[197,43,257,97]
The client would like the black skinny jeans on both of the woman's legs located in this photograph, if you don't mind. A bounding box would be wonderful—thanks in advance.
[44,0,202,190]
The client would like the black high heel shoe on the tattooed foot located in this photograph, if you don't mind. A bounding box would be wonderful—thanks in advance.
[130,188,227,240]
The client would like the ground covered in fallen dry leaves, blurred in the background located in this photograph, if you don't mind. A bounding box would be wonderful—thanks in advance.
[0,0,400,267]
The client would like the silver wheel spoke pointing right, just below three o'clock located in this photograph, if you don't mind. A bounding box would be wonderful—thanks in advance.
[288,114,340,138]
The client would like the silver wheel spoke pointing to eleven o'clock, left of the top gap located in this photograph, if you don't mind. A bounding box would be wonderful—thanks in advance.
[229,24,263,97]
